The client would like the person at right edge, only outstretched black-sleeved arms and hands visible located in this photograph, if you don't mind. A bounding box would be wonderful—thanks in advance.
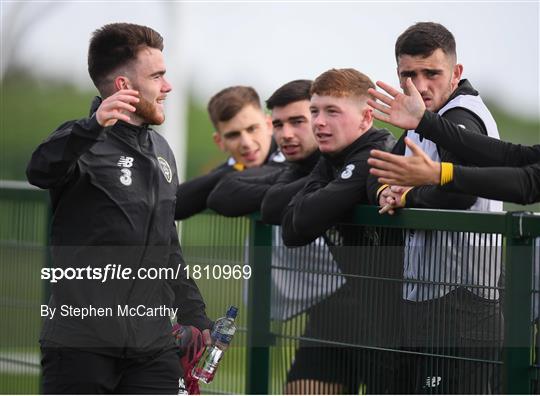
[368,72,540,393]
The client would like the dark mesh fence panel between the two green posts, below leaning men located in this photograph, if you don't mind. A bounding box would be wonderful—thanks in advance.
[271,225,502,394]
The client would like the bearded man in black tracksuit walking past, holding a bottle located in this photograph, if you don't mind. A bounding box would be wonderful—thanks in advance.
[27,23,211,394]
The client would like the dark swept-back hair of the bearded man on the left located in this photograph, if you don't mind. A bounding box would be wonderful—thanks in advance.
[88,23,163,94]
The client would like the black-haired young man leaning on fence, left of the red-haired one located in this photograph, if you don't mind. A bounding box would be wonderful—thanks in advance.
[208,80,347,394]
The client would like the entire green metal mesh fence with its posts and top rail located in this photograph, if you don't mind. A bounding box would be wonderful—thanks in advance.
[0,182,540,394]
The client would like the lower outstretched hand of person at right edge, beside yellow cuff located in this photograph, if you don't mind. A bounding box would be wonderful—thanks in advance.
[368,138,441,186]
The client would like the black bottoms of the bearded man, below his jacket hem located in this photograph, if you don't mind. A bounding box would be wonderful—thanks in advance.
[41,347,182,395]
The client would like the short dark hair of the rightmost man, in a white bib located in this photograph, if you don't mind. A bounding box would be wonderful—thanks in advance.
[395,22,456,61]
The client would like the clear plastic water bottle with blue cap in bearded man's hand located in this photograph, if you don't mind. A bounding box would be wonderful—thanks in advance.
[191,306,238,384]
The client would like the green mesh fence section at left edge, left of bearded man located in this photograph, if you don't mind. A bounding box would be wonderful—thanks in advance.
[0,194,48,394]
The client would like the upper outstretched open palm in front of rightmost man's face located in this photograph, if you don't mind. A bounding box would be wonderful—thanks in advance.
[367,77,426,129]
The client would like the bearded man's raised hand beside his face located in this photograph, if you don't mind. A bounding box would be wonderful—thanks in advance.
[96,89,139,127]
